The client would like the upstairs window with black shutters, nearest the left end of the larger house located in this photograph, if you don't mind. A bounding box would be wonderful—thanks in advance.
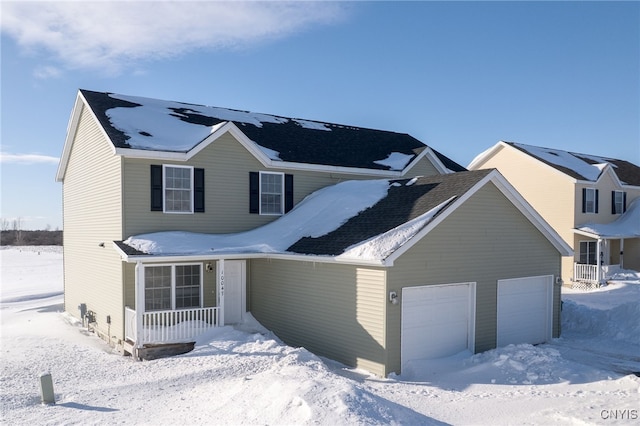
[151,164,204,213]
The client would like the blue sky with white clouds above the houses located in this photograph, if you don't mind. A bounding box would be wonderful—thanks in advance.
[0,1,640,229]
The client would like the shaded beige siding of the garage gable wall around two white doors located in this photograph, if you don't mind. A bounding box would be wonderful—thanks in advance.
[387,183,560,371]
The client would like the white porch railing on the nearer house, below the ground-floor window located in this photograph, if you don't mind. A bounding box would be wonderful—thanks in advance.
[125,307,220,346]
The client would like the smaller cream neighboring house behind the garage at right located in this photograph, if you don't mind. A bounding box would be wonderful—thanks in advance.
[469,142,640,287]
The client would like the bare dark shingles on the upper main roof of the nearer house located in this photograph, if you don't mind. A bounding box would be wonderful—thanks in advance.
[80,90,466,171]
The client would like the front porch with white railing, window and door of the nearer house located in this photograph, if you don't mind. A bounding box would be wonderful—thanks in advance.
[124,257,246,359]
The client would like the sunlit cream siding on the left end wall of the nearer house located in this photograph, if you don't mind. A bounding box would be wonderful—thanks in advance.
[63,108,124,343]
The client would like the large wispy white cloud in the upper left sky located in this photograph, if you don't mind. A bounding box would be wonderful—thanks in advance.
[1,1,347,76]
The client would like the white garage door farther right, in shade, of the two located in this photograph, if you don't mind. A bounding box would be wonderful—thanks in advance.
[497,275,553,346]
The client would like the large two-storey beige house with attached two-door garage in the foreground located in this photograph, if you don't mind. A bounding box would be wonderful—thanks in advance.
[57,90,571,375]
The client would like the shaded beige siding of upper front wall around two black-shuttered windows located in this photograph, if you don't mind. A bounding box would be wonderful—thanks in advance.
[124,133,388,236]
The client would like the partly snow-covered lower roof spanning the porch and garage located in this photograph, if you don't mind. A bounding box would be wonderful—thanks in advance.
[118,170,491,262]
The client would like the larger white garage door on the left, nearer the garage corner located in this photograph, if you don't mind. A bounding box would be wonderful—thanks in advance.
[400,283,475,367]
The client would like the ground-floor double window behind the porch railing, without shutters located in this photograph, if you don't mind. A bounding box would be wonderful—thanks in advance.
[144,265,202,311]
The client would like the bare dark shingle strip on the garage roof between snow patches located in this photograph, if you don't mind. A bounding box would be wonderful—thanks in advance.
[287,169,493,256]
